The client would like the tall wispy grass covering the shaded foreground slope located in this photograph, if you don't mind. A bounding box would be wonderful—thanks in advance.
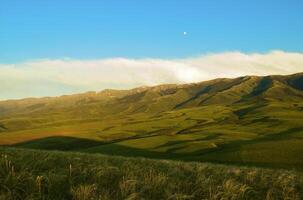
[0,148,303,200]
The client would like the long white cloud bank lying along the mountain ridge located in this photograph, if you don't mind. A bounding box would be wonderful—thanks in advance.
[0,51,303,99]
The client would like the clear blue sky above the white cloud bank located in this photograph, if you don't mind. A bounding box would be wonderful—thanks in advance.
[0,0,303,63]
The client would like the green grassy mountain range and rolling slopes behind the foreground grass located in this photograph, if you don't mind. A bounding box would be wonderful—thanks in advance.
[0,73,303,167]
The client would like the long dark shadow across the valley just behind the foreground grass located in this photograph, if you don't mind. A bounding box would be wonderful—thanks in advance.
[6,127,303,170]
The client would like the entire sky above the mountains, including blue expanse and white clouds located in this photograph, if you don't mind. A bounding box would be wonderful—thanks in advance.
[0,0,303,99]
